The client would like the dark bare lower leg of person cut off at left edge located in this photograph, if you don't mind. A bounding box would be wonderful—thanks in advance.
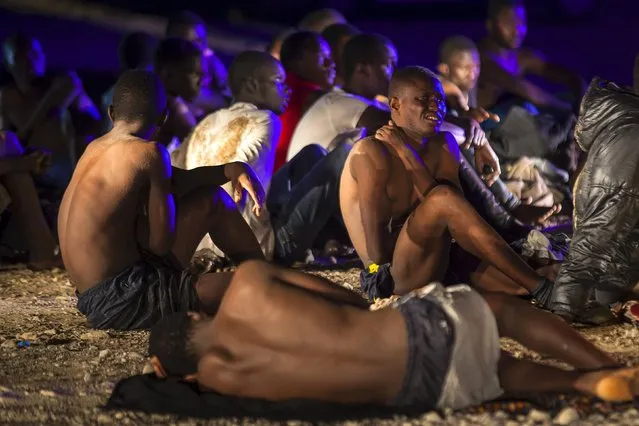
[2,173,62,269]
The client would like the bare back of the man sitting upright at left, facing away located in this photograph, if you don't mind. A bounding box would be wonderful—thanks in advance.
[58,134,155,292]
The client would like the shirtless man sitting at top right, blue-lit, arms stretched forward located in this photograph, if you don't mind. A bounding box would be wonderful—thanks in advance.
[477,0,586,111]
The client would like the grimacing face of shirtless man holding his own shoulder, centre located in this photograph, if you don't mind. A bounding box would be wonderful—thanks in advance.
[392,78,446,137]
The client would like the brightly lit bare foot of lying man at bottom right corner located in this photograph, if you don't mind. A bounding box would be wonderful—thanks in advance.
[575,367,639,402]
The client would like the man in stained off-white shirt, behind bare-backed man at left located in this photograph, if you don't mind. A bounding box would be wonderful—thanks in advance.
[171,51,289,260]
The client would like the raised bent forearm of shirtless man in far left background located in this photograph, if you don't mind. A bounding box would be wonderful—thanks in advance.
[18,73,80,141]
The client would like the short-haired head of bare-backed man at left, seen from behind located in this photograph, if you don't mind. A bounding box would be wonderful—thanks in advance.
[112,70,166,123]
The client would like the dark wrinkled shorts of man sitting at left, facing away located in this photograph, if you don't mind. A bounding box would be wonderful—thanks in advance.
[78,253,199,330]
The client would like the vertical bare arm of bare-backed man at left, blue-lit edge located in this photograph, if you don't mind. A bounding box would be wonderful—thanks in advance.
[147,144,175,256]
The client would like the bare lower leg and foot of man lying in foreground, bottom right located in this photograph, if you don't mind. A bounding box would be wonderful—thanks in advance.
[499,353,639,402]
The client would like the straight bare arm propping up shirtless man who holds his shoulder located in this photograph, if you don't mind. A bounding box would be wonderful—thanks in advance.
[350,139,393,265]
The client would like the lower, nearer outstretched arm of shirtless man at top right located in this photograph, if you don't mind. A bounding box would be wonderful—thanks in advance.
[481,56,572,111]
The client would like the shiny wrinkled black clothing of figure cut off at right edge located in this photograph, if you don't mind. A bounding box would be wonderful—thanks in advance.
[550,78,639,318]
